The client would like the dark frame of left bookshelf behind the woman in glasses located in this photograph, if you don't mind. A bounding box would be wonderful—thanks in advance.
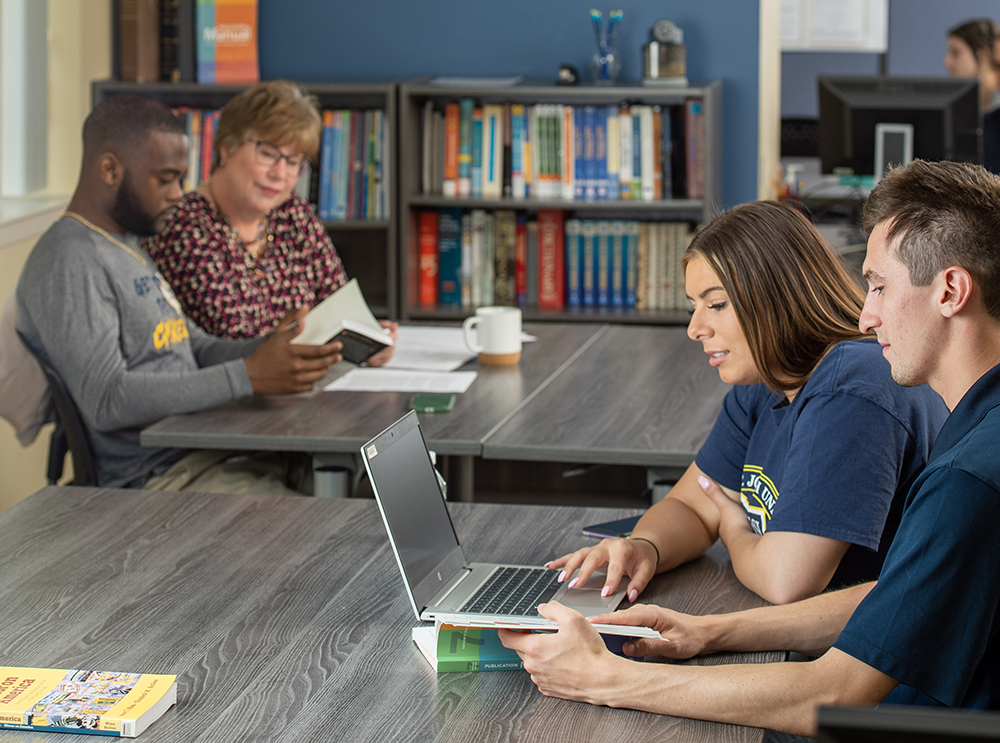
[91,80,399,319]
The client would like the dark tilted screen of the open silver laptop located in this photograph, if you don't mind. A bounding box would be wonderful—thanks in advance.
[362,412,459,598]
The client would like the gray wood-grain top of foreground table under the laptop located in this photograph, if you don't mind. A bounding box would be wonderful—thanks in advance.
[0,488,777,743]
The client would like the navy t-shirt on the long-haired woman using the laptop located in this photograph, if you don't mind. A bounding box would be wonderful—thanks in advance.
[695,340,948,587]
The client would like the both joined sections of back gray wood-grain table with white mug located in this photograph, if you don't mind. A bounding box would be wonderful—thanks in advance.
[142,323,728,467]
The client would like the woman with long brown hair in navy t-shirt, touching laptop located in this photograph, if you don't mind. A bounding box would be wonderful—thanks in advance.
[549,201,947,604]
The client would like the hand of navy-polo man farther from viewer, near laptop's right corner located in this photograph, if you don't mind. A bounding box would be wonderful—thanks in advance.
[590,604,710,660]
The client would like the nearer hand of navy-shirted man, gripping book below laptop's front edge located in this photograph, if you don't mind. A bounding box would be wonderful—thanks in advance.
[499,601,633,704]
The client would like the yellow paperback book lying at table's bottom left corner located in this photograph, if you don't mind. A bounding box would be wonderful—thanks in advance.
[0,666,177,738]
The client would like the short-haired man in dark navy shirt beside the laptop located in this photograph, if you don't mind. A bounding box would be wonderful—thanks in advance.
[501,162,1000,735]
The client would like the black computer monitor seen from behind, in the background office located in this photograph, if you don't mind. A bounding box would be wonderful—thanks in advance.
[819,76,983,180]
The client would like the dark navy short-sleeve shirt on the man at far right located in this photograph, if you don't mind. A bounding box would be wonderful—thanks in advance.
[833,366,1000,709]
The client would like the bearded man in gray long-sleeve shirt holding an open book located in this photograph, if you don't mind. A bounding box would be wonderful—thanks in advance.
[17,96,340,487]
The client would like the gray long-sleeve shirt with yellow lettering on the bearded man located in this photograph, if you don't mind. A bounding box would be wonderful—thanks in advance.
[17,217,262,487]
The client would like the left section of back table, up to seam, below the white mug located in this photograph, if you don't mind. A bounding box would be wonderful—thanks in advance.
[141,323,605,455]
